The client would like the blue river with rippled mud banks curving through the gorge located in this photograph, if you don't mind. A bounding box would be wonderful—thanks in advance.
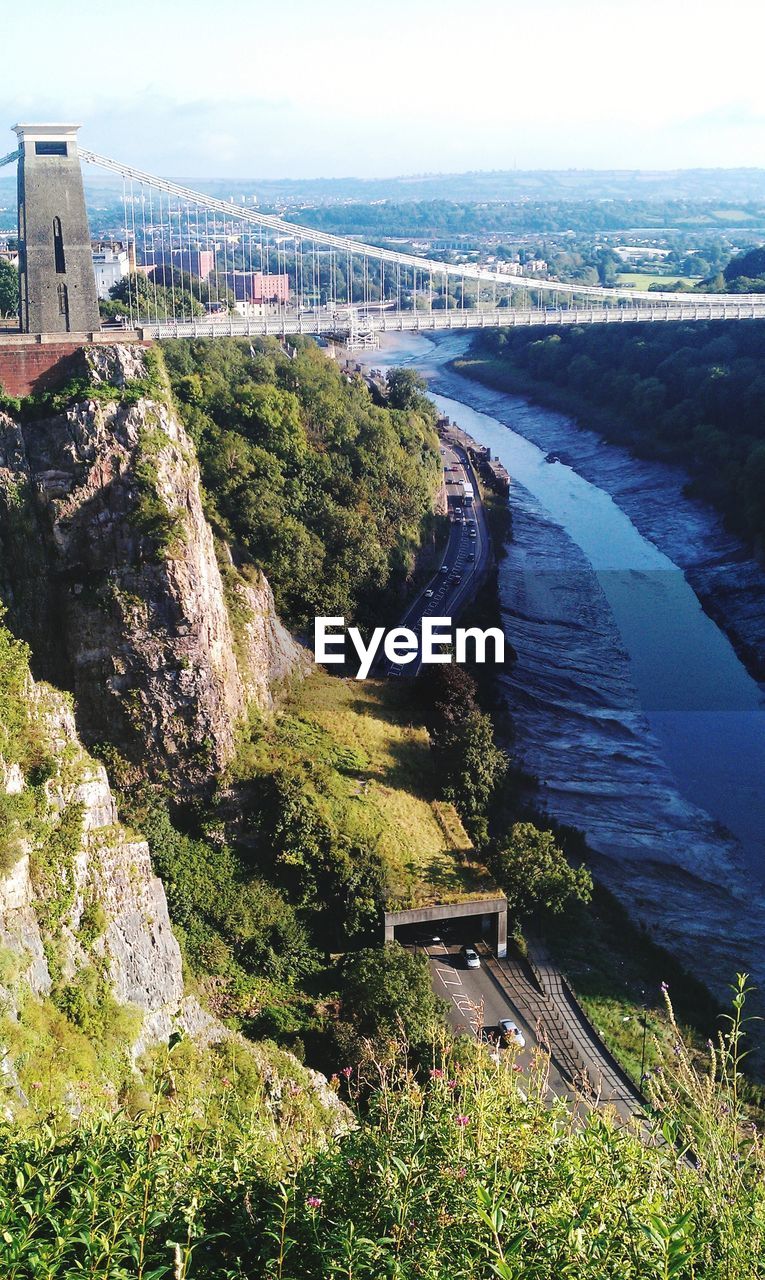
[355,334,765,1008]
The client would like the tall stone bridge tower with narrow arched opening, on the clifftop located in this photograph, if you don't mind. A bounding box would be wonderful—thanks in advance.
[15,124,101,333]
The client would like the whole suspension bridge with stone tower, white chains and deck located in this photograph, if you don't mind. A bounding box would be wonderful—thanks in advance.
[0,124,765,344]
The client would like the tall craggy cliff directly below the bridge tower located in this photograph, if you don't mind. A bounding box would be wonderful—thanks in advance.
[0,346,304,786]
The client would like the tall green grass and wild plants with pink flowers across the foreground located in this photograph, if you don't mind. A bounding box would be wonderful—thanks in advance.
[0,982,765,1280]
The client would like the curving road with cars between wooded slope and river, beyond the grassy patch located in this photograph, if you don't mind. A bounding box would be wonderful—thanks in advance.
[384,442,491,676]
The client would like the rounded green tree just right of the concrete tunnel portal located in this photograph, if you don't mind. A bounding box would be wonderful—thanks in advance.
[489,822,592,919]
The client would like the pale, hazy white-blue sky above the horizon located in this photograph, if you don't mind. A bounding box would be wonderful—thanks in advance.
[0,0,765,178]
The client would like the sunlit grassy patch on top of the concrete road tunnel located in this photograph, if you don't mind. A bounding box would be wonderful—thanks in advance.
[248,671,496,909]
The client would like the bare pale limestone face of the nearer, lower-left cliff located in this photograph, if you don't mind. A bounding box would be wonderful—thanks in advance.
[0,684,183,1043]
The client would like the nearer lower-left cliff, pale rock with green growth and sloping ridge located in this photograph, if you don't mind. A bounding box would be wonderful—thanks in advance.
[0,637,348,1142]
